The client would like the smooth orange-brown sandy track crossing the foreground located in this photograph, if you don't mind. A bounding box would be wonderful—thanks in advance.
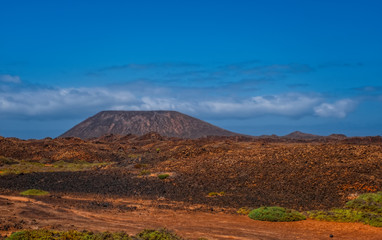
[0,195,382,240]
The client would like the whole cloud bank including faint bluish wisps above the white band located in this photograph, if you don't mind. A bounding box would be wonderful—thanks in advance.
[0,61,362,122]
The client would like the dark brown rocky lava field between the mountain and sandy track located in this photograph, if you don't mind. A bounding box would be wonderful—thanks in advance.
[0,134,382,239]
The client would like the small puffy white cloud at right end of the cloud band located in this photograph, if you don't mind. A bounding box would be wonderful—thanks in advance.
[314,99,356,118]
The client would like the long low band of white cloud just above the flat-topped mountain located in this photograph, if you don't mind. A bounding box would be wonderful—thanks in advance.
[0,82,356,119]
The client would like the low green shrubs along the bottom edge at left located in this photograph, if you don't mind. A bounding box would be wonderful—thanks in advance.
[7,229,132,240]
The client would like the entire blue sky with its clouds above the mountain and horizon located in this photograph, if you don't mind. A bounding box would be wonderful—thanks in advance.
[0,0,382,138]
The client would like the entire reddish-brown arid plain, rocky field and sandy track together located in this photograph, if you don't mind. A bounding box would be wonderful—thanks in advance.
[0,133,382,239]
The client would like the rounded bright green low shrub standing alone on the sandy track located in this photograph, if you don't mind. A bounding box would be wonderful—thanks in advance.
[248,207,306,222]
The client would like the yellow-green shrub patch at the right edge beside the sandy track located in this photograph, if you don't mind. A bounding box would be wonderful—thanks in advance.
[308,192,382,227]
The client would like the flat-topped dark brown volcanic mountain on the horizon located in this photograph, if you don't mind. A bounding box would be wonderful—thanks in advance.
[59,111,240,139]
